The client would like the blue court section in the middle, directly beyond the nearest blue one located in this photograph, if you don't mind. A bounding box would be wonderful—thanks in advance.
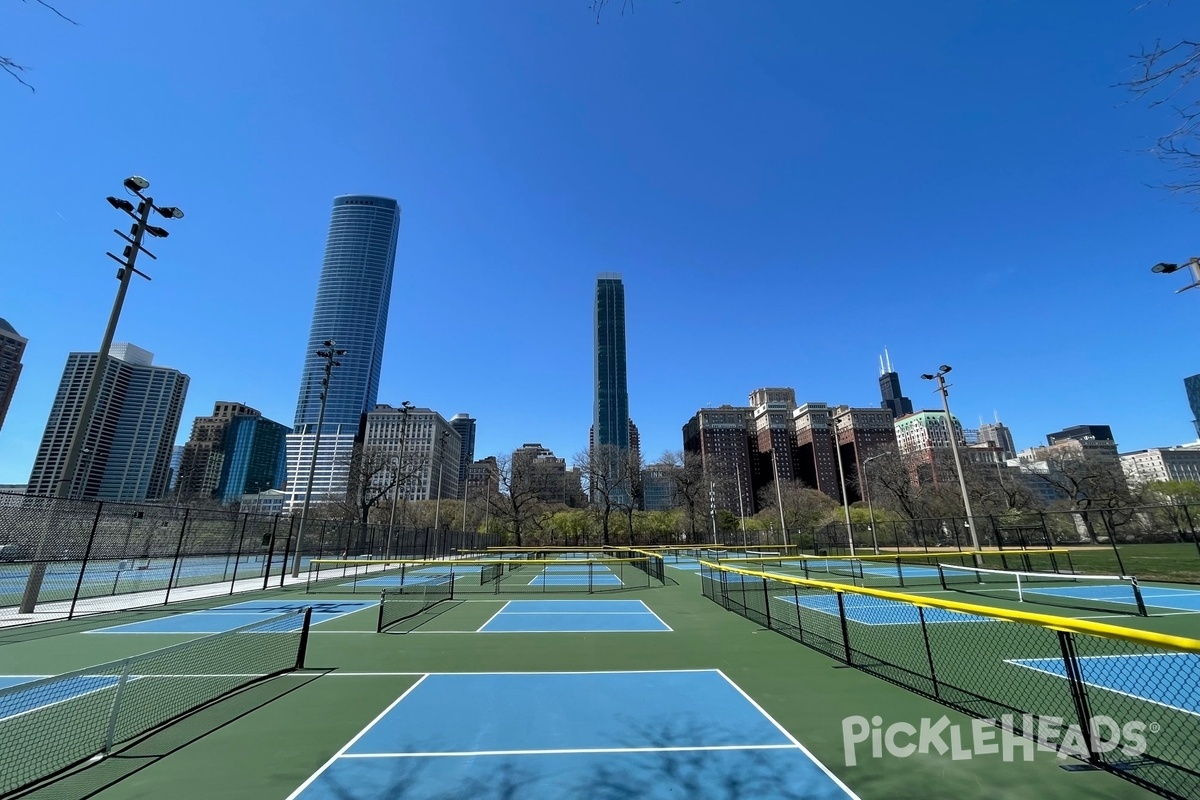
[479,600,671,633]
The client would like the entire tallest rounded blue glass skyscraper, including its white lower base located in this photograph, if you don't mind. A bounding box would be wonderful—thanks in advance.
[287,194,400,511]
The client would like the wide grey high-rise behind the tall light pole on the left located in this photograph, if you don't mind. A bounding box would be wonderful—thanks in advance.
[28,343,190,501]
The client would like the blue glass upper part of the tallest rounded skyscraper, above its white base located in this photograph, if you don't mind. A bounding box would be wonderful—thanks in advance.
[295,194,400,433]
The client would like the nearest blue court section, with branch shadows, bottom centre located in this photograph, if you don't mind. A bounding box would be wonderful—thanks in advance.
[288,670,856,800]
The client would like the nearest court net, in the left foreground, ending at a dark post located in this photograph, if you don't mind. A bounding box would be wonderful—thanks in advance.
[0,608,311,796]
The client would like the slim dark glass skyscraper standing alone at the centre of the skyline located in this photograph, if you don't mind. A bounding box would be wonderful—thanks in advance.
[592,272,629,450]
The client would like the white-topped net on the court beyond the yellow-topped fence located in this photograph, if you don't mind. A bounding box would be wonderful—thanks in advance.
[937,564,1147,616]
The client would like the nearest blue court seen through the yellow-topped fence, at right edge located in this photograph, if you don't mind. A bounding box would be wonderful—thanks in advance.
[1007,652,1200,715]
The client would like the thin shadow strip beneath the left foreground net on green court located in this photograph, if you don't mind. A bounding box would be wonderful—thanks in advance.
[15,670,329,800]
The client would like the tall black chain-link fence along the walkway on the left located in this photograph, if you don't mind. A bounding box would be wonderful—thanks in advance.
[0,494,498,621]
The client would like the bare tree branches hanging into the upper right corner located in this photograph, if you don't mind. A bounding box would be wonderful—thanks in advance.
[1122,24,1200,201]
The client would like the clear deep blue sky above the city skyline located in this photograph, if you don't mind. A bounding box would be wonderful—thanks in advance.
[0,0,1200,483]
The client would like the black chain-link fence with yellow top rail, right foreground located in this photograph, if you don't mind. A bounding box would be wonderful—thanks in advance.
[701,563,1200,799]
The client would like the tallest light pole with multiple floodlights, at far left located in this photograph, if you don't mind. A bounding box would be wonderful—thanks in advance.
[18,175,184,614]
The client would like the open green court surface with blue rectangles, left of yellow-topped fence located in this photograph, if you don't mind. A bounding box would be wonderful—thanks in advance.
[0,570,1185,800]
